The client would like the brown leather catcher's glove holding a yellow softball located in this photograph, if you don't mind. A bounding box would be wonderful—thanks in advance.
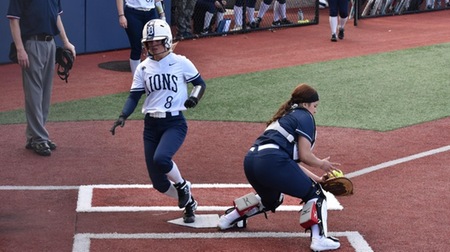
[320,171,353,196]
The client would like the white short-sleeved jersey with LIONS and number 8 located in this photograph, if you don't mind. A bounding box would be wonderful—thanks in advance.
[131,53,200,114]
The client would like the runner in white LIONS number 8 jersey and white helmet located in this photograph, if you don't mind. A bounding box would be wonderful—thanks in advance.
[111,19,206,223]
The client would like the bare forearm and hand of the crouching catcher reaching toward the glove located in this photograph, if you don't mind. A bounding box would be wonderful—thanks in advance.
[298,136,339,172]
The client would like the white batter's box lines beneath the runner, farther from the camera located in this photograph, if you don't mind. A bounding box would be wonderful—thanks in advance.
[76,184,344,212]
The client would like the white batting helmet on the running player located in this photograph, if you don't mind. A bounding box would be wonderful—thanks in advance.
[141,19,172,50]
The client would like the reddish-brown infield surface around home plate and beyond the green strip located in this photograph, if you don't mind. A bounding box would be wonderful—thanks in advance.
[0,8,450,252]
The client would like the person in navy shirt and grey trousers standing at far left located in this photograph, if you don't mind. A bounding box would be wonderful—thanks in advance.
[7,0,76,156]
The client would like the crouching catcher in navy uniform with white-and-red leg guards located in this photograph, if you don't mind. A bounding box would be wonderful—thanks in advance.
[218,84,340,251]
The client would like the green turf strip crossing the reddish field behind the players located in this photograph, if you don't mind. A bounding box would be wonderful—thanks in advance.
[0,43,450,131]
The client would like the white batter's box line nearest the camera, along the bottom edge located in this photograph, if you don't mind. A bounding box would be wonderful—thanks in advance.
[72,231,373,252]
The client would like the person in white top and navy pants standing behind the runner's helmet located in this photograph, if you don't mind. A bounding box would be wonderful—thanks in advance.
[116,0,166,76]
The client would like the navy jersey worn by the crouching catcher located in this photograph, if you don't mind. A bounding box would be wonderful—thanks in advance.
[255,108,316,157]
